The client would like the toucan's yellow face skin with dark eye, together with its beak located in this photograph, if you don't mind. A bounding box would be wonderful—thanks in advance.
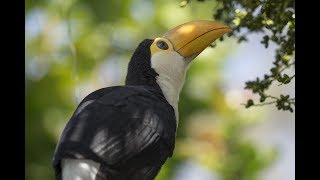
[150,20,231,63]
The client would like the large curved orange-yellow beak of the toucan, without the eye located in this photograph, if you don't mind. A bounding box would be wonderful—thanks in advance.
[162,20,232,58]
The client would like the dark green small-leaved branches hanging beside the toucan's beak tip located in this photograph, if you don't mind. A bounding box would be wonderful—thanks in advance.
[183,0,295,112]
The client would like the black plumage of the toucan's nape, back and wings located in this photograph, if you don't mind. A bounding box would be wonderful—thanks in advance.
[53,40,176,180]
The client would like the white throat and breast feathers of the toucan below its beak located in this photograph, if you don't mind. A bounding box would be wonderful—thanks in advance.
[151,51,189,126]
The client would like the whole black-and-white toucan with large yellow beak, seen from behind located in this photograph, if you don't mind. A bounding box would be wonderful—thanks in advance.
[52,20,232,180]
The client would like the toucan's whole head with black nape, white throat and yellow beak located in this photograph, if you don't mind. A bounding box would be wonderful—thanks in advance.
[126,20,231,115]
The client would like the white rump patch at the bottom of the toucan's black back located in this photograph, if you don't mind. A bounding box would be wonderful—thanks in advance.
[61,159,100,180]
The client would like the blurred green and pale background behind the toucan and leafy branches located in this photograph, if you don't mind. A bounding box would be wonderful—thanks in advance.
[25,0,295,180]
